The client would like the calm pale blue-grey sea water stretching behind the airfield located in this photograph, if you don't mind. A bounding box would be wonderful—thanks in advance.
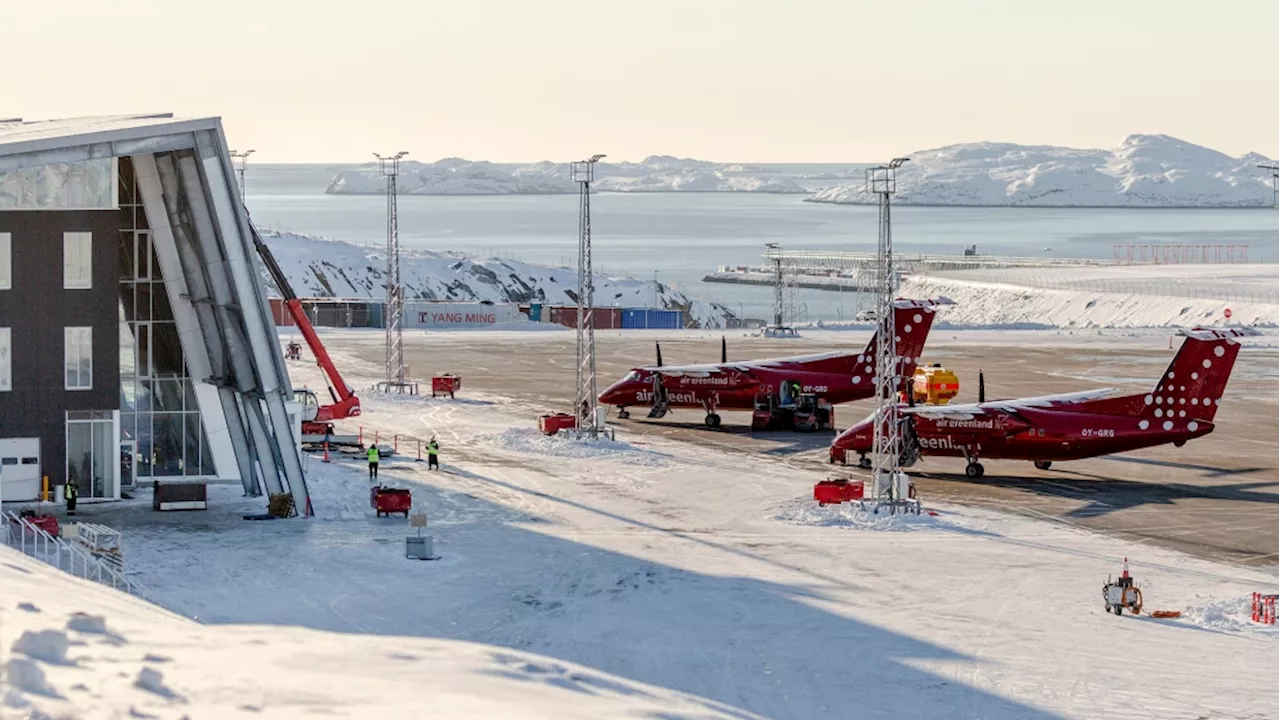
[247,165,1280,320]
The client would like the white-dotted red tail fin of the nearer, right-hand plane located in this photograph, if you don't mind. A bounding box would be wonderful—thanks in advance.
[1140,328,1260,424]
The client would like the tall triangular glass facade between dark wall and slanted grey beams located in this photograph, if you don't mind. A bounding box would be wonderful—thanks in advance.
[119,159,218,483]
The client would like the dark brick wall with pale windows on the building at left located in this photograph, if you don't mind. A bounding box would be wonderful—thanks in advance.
[0,210,123,483]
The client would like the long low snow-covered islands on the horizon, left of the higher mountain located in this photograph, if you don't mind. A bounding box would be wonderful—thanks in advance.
[325,155,808,195]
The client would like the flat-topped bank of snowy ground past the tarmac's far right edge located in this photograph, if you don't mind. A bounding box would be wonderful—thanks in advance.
[899,265,1280,328]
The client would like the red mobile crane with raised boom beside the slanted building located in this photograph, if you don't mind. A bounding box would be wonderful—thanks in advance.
[250,223,360,445]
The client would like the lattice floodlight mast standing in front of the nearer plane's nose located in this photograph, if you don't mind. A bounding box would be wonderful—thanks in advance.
[867,158,910,507]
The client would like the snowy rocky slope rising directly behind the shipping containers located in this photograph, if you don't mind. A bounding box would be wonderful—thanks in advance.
[261,231,732,328]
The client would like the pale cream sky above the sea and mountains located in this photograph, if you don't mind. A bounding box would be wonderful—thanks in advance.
[0,0,1280,161]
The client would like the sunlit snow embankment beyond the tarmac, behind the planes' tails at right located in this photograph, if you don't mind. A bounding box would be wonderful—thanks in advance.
[900,265,1280,329]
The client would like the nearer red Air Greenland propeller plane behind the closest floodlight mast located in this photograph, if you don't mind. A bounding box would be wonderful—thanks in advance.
[831,328,1258,478]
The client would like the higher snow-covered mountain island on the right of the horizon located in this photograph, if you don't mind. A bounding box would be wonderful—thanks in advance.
[809,135,1272,208]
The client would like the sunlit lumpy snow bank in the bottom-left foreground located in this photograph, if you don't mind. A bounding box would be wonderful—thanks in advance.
[0,546,754,720]
